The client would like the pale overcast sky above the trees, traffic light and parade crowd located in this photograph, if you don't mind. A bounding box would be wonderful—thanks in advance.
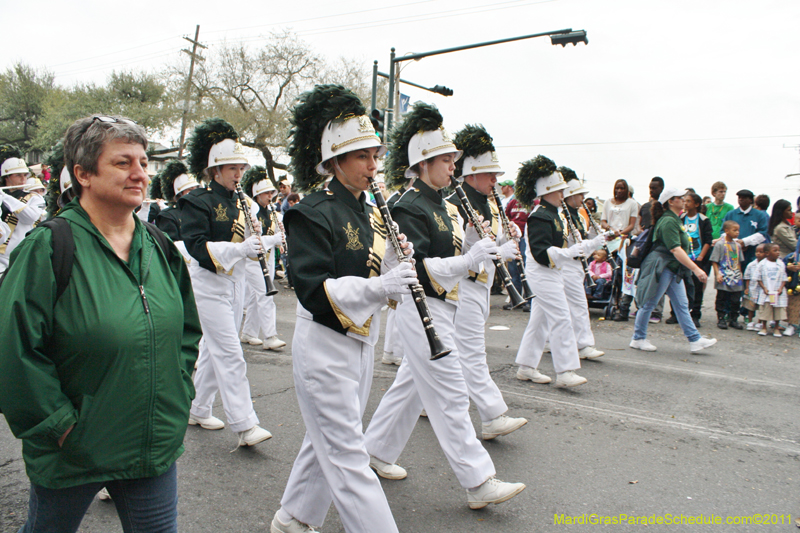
[0,0,800,204]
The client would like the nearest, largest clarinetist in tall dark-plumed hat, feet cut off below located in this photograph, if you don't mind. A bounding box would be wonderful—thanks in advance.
[270,85,419,533]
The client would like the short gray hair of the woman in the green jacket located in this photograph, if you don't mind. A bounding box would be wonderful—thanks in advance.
[64,115,147,197]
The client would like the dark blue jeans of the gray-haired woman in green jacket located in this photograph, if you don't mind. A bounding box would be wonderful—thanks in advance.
[19,463,178,533]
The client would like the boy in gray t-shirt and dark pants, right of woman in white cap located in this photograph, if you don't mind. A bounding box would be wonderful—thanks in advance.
[711,220,744,329]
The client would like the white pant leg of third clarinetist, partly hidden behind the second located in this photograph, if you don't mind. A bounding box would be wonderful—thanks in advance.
[456,280,508,423]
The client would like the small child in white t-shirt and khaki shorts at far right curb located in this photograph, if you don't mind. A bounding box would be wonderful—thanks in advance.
[755,243,789,337]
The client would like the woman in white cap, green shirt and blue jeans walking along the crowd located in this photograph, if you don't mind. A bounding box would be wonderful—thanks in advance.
[630,187,717,353]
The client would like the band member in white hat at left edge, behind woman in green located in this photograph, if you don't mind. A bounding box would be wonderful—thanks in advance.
[0,153,45,272]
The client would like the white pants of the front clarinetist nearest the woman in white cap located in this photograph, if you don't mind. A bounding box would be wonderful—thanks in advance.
[516,257,581,373]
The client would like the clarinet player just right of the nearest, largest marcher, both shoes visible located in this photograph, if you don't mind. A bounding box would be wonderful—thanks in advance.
[365,103,525,509]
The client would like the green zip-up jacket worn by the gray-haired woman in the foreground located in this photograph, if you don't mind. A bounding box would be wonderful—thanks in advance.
[0,199,201,489]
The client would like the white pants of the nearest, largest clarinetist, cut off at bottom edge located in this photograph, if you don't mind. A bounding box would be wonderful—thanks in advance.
[281,317,398,533]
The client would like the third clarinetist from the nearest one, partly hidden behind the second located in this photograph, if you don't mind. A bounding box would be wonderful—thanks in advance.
[447,126,528,440]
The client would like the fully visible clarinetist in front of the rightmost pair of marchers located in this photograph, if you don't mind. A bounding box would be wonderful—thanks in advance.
[515,155,605,387]
